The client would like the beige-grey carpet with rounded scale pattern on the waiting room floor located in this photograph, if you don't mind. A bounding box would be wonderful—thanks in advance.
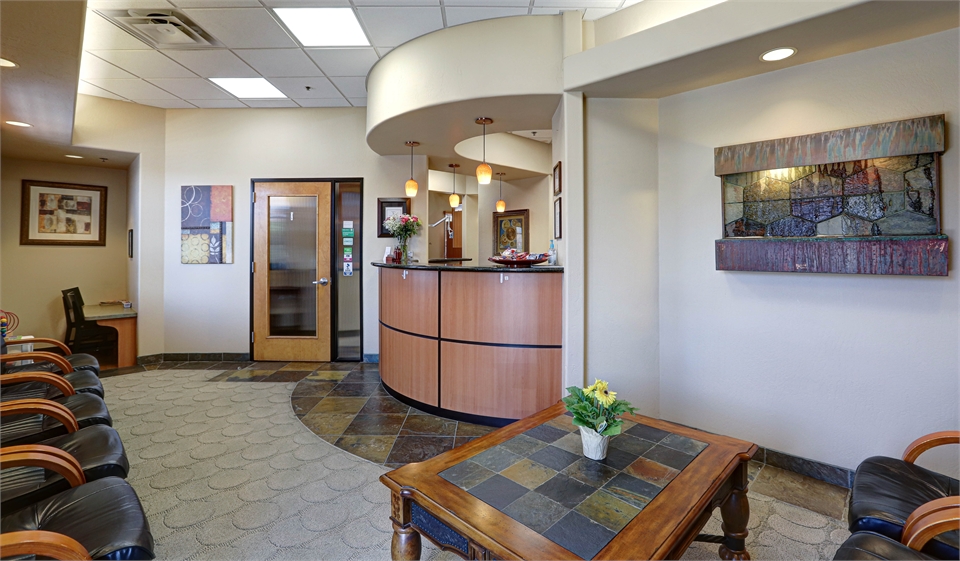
[103,370,848,560]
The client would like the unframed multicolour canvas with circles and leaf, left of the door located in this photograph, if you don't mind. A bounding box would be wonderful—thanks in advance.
[180,185,233,265]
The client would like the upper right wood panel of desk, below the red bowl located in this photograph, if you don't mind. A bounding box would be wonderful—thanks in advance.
[440,270,563,346]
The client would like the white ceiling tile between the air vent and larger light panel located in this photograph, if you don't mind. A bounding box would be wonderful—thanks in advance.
[184,8,297,49]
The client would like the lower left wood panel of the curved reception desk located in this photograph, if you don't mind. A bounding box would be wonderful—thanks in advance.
[380,325,440,407]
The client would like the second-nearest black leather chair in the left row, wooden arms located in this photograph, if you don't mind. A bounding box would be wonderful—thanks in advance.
[0,425,130,512]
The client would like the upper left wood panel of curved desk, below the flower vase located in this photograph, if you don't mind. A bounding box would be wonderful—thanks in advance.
[380,269,440,337]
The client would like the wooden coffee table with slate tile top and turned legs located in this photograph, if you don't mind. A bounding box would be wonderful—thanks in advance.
[380,403,757,560]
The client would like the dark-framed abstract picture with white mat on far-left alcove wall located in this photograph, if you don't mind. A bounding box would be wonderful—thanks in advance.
[20,179,107,246]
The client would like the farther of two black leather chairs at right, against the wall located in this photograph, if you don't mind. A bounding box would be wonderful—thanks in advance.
[848,431,960,559]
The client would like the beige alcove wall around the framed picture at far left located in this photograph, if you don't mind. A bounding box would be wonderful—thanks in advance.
[0,158,128,340]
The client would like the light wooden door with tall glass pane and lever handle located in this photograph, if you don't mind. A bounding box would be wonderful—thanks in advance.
[253,181,333,361]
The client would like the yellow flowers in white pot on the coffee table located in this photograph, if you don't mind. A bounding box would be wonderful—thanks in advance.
[563,379,636,460]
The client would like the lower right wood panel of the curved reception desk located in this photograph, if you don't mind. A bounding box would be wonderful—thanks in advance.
[440,341,563,419]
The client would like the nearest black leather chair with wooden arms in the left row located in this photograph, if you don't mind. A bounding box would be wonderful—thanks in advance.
[0,446,154,559]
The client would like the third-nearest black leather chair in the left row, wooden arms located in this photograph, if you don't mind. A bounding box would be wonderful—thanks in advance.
[0,393,113,446]
